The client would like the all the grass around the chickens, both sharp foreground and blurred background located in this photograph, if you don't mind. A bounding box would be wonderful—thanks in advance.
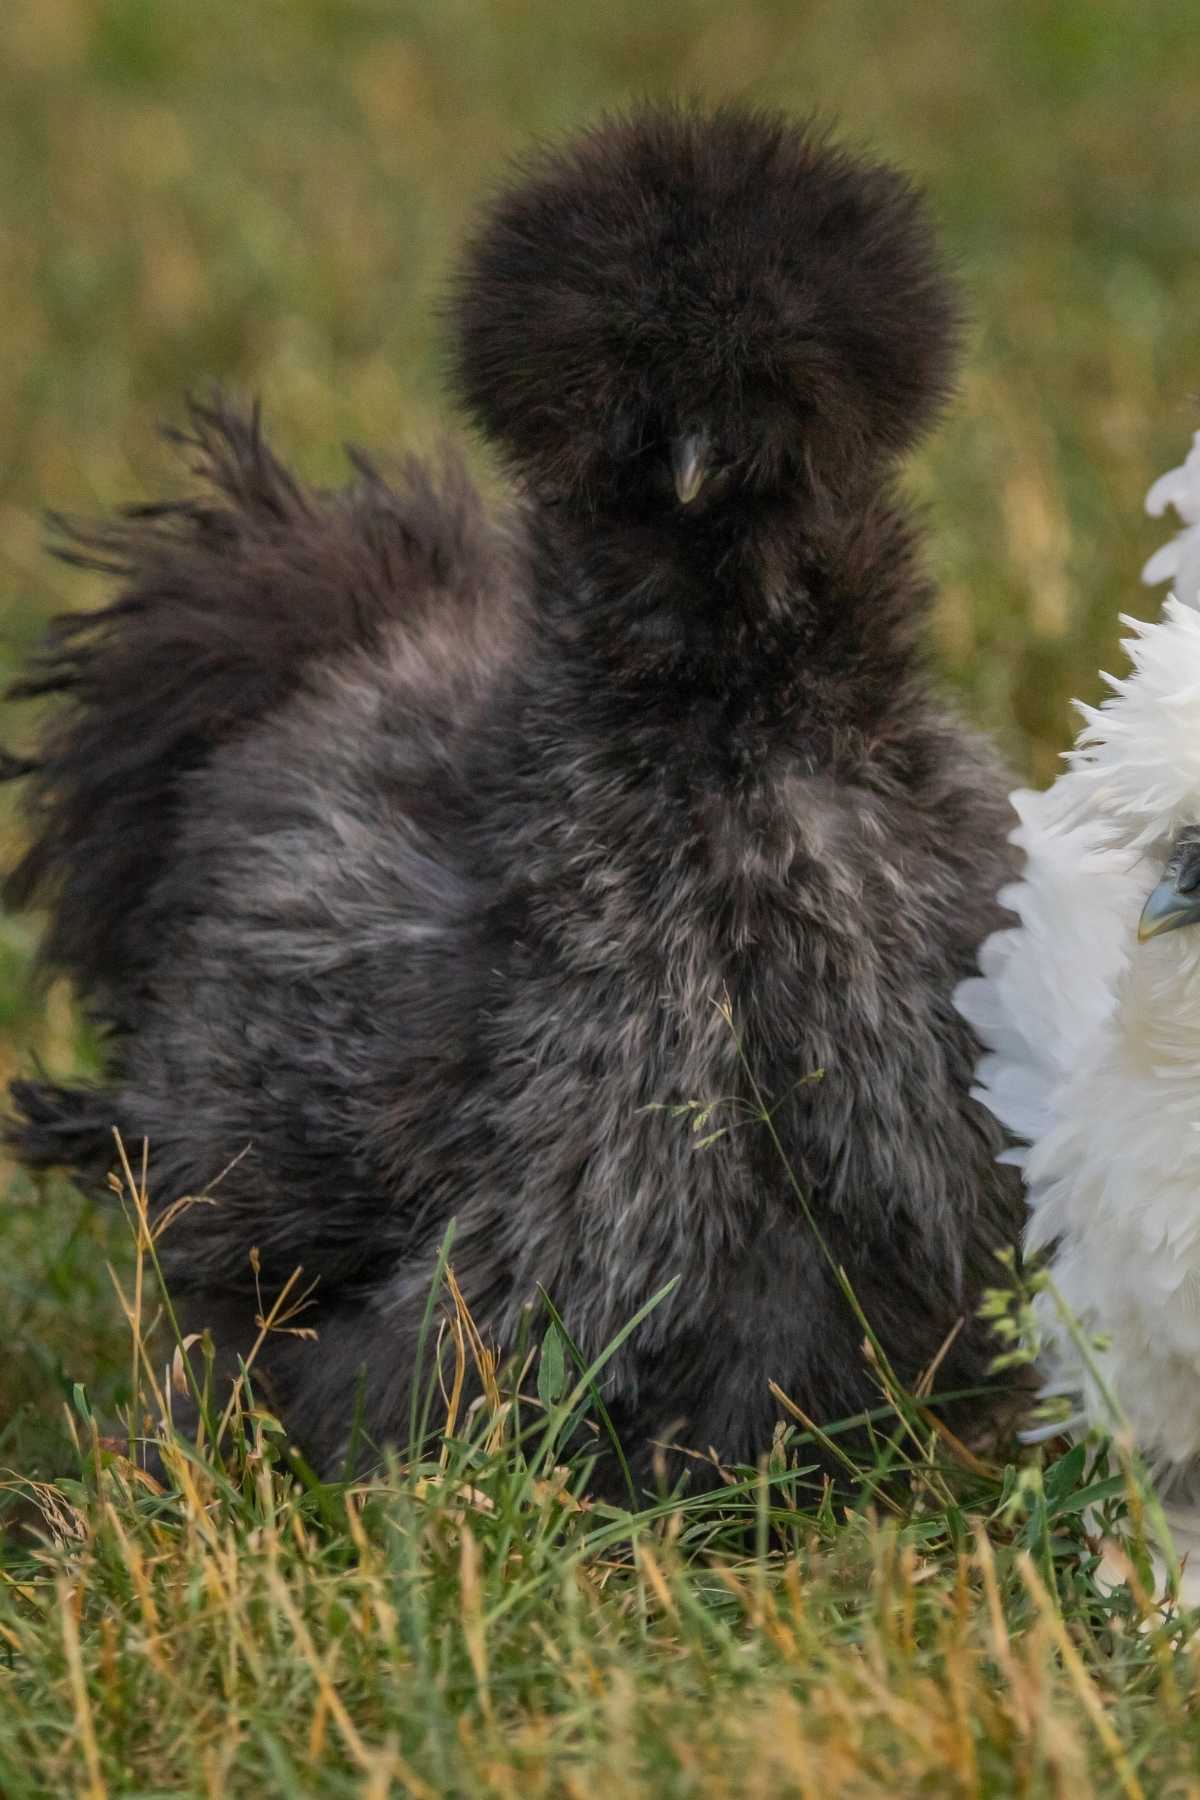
[0,0,1200,1800]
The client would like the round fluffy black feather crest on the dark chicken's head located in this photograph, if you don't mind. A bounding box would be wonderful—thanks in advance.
[453,106,959,506]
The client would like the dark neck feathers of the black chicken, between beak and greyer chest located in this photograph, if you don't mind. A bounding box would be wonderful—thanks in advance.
[534,495,930,767]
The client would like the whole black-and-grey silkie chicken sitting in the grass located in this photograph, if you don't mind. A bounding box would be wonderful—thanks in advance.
[9,110,1020,1492]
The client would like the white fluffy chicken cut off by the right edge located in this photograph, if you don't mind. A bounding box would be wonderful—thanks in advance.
[957,432,1200,1600]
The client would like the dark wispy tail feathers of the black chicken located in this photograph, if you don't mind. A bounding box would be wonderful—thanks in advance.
[0,398,491,1024]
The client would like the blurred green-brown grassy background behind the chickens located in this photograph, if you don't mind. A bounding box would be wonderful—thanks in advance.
[0,0,1200,1454]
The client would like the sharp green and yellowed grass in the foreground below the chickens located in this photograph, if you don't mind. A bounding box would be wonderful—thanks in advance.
[0,1165,1200,1800]
